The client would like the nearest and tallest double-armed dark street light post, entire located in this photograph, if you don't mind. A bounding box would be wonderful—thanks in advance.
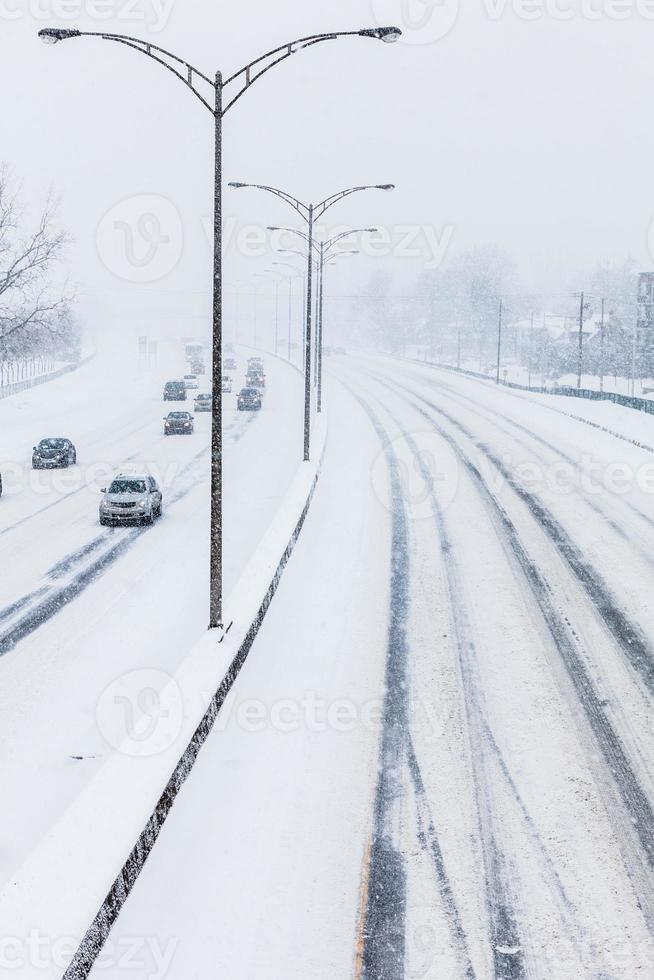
[39,27,402,629]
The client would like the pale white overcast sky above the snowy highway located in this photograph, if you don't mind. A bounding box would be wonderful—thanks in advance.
[0,0,654,336]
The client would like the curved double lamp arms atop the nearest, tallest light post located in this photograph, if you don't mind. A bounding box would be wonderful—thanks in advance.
[39,27,402,117]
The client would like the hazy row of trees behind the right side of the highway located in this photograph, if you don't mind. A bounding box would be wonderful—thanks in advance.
[357,245,654,381]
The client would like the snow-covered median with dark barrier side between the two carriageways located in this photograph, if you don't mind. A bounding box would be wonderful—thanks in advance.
[0,419,326,977]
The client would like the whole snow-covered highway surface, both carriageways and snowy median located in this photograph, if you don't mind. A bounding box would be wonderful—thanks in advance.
[0,342,654,980]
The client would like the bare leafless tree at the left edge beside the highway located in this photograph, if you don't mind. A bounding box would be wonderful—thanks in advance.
[0,167,79,386]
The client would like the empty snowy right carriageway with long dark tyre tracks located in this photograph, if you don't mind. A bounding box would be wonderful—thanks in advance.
[77,357,654,980]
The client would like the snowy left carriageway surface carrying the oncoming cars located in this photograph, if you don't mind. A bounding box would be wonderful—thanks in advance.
[0,344,302,881]
